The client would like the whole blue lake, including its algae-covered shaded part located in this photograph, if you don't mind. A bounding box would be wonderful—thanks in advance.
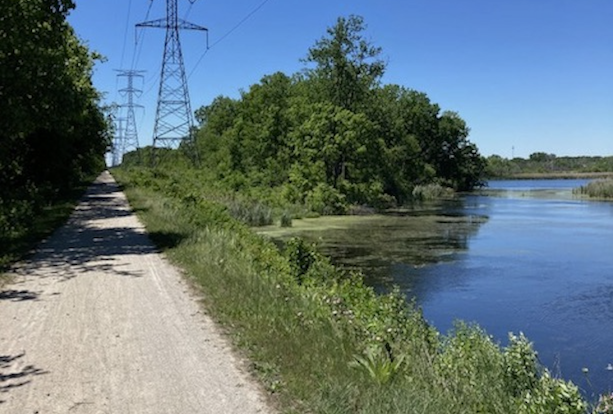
[262,180,613,397]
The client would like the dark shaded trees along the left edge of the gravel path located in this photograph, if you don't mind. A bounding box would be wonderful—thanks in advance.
[0,0,109,267]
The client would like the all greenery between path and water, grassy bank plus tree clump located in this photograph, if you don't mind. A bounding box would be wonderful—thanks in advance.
[113,16,608,414]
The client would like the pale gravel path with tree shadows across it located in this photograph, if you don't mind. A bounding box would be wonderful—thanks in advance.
[0,172,271,414]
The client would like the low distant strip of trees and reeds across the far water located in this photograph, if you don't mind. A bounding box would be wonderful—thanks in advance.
[485,152,613,178]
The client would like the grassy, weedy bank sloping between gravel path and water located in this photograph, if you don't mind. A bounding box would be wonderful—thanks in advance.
[113,167,587,414]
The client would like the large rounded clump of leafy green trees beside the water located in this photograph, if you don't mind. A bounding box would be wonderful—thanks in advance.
[124,16,485,213]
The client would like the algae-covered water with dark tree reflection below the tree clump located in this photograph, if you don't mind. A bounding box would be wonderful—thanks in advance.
[267,199,487,292]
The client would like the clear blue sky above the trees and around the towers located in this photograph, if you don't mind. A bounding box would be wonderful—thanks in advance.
[69,0,613,158]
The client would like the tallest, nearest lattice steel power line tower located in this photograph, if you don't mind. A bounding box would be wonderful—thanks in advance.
[136,0,208,148]
